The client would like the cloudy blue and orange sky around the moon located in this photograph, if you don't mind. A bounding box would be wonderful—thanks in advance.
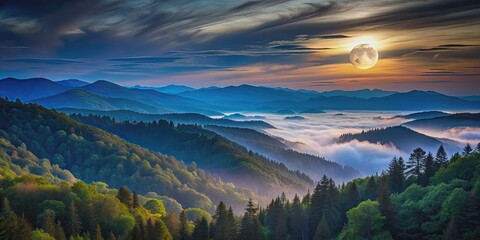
[0,0,480,96]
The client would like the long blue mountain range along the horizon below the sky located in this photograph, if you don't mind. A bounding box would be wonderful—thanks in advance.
[0,78,480,113]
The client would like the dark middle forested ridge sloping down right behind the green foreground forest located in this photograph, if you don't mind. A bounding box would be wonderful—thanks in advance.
[71,115,313,196]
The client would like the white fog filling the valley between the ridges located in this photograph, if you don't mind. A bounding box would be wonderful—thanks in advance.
[226,111,480,175]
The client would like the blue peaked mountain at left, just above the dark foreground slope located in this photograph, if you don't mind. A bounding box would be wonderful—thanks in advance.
[31,89,166,113]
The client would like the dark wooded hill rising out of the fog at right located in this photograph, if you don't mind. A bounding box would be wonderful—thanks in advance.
[337,126,452,153]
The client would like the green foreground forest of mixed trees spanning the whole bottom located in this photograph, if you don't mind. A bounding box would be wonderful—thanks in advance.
[0,100,480,240]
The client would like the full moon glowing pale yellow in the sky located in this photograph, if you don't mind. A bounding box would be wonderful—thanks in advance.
[350,44,378,69]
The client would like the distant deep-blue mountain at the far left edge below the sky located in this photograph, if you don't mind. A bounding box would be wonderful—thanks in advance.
[0,78,70,101]
